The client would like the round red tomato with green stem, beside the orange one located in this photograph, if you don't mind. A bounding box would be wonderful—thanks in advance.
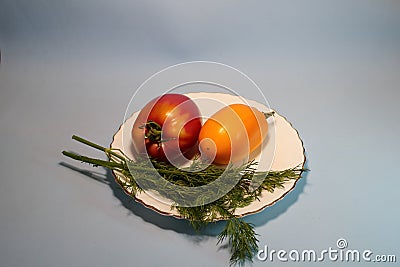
[132,94,201,162]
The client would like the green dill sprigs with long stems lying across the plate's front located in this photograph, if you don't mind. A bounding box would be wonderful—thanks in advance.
[62,135,306,265]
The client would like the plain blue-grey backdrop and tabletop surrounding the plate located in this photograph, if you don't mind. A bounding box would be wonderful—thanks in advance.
[0,0,400,266]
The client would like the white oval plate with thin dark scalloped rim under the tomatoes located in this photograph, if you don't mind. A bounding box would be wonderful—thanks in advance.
[111,93,306,218]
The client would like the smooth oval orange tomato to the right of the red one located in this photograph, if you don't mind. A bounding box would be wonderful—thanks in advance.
[199,104,268,165]
